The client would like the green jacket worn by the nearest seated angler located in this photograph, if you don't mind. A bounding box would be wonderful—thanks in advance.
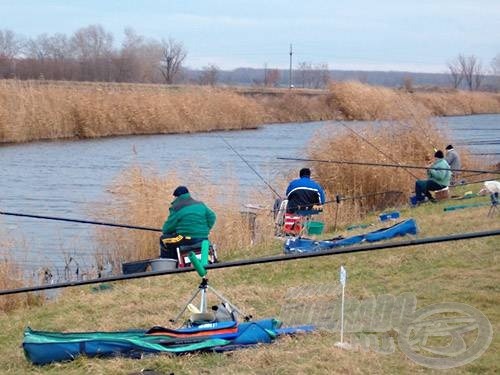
[162,193,216,238]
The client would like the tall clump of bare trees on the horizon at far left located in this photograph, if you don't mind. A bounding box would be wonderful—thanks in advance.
[0,25,187,83]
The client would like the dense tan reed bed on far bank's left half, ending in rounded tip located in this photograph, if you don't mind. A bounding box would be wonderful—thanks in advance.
[0,81,264,142]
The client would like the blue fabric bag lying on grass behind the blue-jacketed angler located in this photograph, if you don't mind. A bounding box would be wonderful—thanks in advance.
[284,219,418,254]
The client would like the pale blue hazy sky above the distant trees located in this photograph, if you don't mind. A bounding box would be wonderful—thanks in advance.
[0,0,500,73]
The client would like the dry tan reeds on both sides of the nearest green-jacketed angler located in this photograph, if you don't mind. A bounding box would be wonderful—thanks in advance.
[91,166,274,268]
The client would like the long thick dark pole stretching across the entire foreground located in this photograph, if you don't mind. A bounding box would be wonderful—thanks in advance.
[0,229,500,296]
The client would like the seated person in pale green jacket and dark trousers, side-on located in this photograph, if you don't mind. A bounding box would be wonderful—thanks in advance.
[415,150,451,202]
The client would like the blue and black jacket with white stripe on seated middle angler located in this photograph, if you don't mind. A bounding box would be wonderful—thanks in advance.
[286,177,325,212]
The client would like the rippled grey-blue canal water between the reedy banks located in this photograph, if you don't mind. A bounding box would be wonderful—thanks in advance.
[0,115,500,279]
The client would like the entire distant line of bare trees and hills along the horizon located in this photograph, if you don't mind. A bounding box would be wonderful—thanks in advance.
[0,25,500,91]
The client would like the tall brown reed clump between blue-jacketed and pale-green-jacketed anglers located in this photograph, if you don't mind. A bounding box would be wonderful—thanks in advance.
[309,117,484,228]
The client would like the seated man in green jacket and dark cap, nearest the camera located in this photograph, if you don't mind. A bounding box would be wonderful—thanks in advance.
[160,186,216,259]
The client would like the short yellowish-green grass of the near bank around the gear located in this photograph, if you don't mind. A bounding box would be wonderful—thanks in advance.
[0,188,500,374]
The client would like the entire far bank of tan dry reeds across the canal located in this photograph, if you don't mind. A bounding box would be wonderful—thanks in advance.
[0,80,500,143]
